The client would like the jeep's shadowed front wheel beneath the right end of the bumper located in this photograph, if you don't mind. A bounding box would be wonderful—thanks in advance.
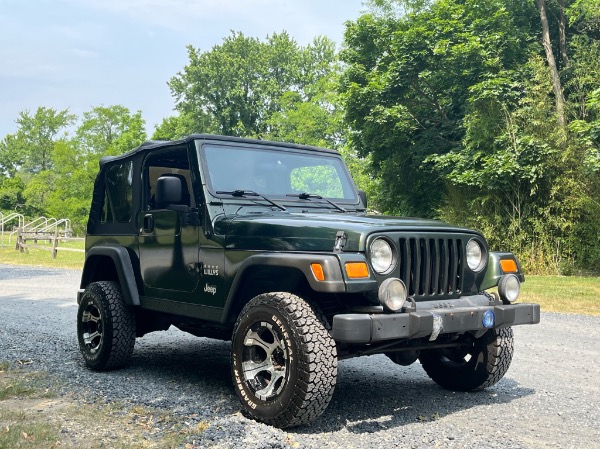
[419,327,514,391]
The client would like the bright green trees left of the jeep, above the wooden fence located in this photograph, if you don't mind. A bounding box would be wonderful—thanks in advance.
[0,106,146,233]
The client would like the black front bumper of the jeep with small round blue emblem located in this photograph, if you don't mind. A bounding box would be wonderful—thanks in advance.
[331,304,540,343]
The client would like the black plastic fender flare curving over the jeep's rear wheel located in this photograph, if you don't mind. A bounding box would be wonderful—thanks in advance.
[78,246,140,306]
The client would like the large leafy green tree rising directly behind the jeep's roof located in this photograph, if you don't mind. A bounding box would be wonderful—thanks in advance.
[168,32,338,138]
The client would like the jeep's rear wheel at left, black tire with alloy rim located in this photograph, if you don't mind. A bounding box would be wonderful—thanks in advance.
[77,281,136,371]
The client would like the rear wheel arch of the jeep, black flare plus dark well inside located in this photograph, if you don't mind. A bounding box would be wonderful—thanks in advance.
[77,246,140,306]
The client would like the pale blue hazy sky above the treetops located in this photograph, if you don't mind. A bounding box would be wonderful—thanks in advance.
[0,0,365,139]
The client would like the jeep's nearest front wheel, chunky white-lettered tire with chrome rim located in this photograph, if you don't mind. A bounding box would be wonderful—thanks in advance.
[231,292,337,428]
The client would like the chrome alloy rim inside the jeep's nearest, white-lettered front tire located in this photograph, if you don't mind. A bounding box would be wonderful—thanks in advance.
[242,322,289,401]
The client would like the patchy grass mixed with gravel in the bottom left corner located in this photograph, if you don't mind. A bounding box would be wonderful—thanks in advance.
[0,362,210,449]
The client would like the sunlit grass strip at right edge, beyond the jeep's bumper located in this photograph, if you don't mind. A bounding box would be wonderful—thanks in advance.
[519,276,600,316]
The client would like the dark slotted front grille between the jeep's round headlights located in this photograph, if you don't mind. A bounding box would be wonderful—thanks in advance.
[398,237,464,297]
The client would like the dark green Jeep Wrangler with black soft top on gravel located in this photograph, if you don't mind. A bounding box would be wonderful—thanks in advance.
[77,135,540,428]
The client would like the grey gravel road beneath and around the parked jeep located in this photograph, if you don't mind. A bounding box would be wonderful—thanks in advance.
[0,264,600,449]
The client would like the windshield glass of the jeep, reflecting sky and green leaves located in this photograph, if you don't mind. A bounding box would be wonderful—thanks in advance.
[203,145,356,202]
